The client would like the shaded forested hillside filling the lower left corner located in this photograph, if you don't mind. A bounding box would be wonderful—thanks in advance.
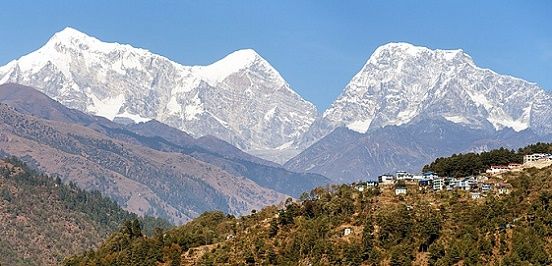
[0,158,170,265]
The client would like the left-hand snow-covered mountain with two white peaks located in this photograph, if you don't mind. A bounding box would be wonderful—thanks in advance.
[0,28,317,162]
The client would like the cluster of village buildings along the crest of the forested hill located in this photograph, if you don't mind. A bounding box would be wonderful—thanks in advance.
[353,153,552,200]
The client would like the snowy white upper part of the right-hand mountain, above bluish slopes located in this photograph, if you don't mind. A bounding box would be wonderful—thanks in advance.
[306,43,552,142]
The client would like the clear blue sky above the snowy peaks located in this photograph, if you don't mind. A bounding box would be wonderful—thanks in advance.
[0,0,552,110]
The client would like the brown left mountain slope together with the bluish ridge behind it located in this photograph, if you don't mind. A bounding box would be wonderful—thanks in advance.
[0,84,328,223]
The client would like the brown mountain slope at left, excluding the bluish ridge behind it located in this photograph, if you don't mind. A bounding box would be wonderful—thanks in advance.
[0,84,286,223]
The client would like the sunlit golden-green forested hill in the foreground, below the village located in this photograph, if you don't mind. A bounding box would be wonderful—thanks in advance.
[65,162,552,265]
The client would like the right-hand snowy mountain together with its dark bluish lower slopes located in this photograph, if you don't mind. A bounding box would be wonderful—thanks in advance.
[286,43,552,182]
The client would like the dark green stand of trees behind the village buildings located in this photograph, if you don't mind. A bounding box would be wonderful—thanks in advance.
[423,142,552,177]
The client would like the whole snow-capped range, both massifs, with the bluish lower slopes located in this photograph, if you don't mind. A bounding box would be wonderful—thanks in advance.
[0,28,552,195]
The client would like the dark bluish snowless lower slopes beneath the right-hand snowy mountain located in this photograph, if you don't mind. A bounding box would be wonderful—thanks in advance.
[285,119,552,183]
